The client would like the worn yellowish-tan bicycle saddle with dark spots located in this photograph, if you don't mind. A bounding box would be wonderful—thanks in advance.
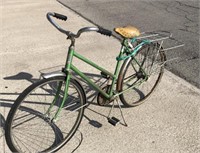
[114,26,140,38]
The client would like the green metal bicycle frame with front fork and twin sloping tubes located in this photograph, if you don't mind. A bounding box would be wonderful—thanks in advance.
[52,39,147,119]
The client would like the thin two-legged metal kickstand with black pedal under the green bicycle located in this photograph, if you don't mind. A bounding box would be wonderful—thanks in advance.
[107,98,128,126]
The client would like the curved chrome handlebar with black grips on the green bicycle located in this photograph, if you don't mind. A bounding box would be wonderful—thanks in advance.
[47,12,112,38]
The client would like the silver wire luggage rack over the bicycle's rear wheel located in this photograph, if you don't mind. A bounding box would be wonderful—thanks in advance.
[127,31,184,75]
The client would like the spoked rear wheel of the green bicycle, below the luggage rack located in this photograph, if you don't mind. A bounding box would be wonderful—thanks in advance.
[117,44,166,106]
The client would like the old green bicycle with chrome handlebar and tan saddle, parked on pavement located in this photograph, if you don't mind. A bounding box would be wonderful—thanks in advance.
[5,12,183,152]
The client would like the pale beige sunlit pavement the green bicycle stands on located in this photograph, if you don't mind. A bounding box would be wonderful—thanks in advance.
[0,0,200,153]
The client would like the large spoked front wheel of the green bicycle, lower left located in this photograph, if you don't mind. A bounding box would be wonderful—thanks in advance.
[5,76,86,152]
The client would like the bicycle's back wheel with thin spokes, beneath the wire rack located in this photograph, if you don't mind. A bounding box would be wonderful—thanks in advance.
[117,43,166,107]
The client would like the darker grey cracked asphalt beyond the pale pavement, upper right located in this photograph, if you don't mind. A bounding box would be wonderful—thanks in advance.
[59,0,200,88]
